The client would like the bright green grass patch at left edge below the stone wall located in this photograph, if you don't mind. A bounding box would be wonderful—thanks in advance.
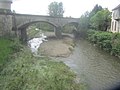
[0,38,21,67]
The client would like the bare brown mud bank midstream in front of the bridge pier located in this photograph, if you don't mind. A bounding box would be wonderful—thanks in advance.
[39,36,75,57]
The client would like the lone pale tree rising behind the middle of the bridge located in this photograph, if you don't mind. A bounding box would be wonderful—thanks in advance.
[48,2,64,17]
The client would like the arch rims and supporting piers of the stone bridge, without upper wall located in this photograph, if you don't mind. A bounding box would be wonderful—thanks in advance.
[18,21,78,41]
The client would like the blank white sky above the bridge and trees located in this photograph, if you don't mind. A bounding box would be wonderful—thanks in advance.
[12,0,120,18]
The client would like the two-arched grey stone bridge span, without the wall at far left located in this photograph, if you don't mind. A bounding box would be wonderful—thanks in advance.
[12,14,79,41]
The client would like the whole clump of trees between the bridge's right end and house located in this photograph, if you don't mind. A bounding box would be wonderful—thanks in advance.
[79,4,111,37]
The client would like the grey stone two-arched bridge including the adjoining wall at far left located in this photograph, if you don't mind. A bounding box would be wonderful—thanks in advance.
[0,13,79,41]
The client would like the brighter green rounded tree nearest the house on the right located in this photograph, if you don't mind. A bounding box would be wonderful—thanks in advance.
[90,8,111,31]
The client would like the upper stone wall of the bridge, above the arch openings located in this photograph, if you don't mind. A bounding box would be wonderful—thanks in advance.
[15,14,79,28]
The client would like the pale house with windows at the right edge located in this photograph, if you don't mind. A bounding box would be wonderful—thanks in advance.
[111,4,120,33]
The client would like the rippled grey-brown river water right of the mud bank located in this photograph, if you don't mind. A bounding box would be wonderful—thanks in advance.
[59,40,120,90]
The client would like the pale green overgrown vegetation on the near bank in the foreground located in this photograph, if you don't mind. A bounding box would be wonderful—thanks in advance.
[0,48,86,90]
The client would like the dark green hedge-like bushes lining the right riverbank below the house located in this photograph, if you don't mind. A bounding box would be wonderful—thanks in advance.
[88,30,120,56]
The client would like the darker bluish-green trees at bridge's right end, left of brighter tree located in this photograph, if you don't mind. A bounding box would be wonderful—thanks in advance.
[78,4,103,38]
